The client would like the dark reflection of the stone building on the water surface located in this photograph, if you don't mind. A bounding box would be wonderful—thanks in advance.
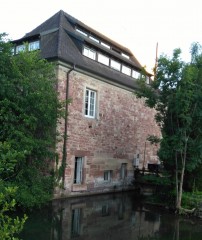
[51,195,160,240]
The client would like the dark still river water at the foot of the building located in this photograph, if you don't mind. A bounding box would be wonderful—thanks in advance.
[20,192,202,240]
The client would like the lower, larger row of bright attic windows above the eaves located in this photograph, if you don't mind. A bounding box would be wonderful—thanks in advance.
[83,46,149,84]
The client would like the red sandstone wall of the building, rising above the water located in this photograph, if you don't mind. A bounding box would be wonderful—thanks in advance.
[58,64,159,196]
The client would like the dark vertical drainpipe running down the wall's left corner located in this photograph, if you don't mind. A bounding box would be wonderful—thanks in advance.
[61,64,75,189]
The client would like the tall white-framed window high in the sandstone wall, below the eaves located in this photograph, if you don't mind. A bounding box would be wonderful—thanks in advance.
[85,89,96,118]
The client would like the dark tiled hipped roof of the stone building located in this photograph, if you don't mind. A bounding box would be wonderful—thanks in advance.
[13,10,148,88]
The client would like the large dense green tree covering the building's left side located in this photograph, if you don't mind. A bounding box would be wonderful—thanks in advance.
[0,34,62,207]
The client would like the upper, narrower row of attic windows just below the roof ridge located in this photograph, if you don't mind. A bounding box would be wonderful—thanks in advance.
[76,28,130,59]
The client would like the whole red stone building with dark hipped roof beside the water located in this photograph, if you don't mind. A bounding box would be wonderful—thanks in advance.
[13,11,160,197]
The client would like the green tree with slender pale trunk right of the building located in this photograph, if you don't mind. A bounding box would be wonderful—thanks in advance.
[137,44,202,210]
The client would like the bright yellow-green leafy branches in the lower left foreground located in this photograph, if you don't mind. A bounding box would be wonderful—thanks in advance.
[0,142,27,240]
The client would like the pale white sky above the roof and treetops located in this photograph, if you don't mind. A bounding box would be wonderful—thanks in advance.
[0,0,202,71]
